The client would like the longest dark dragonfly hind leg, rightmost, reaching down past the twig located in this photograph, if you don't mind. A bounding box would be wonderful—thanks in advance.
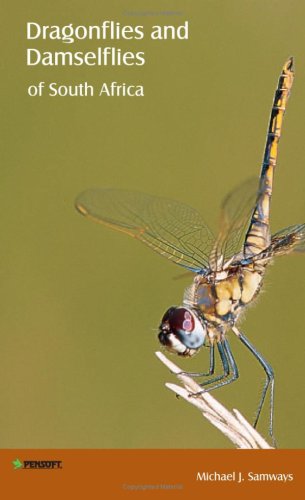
[232,327,275,442]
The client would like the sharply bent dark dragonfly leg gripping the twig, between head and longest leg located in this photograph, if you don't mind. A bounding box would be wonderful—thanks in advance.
[191,339,238,396]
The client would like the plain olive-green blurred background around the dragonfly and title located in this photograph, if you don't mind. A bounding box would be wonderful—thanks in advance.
[0,0,305,448]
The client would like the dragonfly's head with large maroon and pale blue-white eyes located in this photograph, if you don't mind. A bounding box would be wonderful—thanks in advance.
[158,306,207,356]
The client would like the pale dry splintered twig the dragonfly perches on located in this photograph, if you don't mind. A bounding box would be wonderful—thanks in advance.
[156,352,272,449]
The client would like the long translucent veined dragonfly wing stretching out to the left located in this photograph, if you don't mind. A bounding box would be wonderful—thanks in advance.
[76,189,215,272]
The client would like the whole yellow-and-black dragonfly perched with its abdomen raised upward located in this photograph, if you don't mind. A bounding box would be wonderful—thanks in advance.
[76,57,305,440]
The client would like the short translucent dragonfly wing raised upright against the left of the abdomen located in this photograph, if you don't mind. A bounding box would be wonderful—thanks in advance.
[210,177,258,269]
